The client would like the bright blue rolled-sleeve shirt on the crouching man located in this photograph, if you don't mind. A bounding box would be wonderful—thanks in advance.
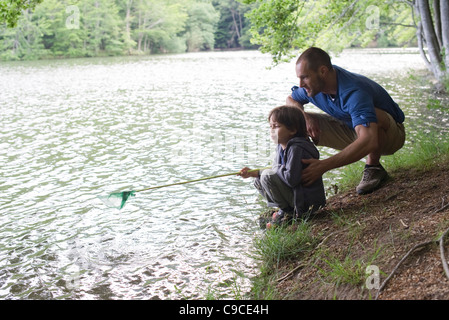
[292,66,404,128]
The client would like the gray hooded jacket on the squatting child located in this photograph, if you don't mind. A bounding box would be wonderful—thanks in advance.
[273,137,326,217]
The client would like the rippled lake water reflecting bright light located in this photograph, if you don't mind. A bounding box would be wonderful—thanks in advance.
[0,50,447,299]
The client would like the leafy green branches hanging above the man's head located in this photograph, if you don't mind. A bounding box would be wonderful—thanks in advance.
[241,0,414,63]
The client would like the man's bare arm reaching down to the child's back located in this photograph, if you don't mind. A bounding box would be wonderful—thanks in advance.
[302,123,379,185]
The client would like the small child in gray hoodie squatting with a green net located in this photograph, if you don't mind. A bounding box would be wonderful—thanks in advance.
[240,106,326,228]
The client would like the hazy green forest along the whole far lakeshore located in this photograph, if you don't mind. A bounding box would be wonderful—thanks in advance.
[0,0,417,60]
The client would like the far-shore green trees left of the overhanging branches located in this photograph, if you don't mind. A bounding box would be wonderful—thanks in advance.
[0,0,251,60]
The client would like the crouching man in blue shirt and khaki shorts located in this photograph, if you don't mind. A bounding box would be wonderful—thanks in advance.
[287,47,405,194]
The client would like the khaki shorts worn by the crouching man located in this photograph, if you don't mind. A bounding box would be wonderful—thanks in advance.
[311,113,405,155]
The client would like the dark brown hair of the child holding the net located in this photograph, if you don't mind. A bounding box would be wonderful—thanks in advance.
[268,106,307,138]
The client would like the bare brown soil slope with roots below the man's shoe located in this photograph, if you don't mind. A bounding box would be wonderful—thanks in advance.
[277,162,449,300]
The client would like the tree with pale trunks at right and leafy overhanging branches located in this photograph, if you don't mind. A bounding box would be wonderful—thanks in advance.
[239,0,449,89]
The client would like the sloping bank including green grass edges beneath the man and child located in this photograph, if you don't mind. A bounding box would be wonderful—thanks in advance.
[247,128,449,299]
